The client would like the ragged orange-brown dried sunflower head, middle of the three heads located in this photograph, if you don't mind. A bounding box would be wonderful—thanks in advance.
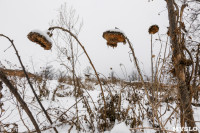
[103,29,126,47]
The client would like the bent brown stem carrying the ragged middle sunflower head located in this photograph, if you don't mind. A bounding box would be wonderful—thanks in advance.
[126,37,164,129]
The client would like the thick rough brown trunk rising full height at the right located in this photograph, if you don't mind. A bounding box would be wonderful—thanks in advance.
[166,0,198,133]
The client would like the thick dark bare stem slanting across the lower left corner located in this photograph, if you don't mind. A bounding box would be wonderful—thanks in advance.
[0,70,41,133]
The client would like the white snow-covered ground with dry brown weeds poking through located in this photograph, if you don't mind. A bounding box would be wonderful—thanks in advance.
[0,78,200,133]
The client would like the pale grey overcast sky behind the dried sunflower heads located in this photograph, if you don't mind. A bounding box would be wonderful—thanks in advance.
[0,0,168,76]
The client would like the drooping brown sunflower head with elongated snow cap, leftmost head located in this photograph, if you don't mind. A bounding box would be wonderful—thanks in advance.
[27,31,52,50]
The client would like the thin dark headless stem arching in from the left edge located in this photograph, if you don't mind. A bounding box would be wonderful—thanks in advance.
[0,34,58,133]
